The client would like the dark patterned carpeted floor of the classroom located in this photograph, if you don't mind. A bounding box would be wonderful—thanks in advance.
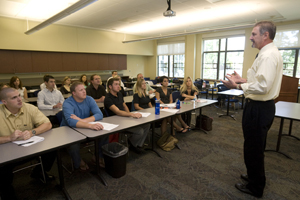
[14,106,300,200]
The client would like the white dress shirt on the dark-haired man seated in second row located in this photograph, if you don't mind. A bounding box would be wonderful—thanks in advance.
[37,88,65,109]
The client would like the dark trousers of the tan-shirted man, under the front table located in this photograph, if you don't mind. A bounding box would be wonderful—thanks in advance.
[0,151,56,200]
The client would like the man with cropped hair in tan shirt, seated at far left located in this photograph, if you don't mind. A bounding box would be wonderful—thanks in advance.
[0,88,56,200]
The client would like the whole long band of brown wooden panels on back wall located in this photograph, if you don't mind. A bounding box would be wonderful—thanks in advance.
[0,50,127,73]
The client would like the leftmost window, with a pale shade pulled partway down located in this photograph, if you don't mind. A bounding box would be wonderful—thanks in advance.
[157,42,185,78]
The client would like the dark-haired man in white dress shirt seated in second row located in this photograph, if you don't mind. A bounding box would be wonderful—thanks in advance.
[37,75,64,109]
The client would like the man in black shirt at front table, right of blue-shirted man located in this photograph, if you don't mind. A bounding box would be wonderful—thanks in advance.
[104,78,150,153]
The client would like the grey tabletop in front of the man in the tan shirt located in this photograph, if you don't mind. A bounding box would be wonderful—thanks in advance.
[0,126,86,164]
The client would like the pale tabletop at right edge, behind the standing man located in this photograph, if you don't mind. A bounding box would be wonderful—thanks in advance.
[275,101,300,120]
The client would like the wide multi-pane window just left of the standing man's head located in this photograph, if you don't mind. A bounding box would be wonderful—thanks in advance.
[202,36,245,80]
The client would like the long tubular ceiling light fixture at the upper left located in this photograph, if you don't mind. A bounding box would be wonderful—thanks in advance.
[25,0,98,35]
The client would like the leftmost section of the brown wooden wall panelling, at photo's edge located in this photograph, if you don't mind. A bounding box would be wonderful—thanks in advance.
[0,50,15,73]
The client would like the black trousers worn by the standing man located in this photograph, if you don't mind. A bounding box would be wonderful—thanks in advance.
[242,99,275,196]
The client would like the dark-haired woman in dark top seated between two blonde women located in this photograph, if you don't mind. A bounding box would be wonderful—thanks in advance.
[155,76,190,135]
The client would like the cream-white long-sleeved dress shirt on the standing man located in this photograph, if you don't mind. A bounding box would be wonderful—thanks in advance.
[241,42,283,101]
